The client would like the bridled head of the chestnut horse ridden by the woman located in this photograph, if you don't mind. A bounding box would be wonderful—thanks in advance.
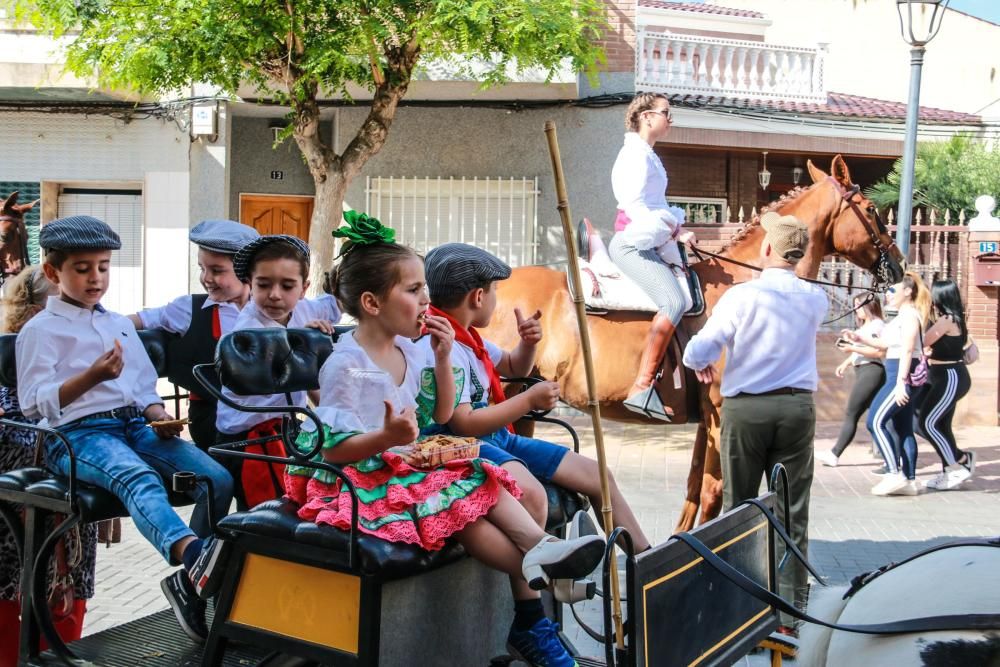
[783,155,905,288]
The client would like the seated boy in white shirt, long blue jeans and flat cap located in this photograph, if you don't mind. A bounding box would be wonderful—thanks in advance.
[16,216,233,641]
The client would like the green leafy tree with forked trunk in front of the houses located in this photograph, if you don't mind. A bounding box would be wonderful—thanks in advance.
[11,0,605,284]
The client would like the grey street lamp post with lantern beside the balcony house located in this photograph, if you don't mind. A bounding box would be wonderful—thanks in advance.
[896,0,951,257]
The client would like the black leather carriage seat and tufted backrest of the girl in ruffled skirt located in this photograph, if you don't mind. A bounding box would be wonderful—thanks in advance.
[216,327,584,579]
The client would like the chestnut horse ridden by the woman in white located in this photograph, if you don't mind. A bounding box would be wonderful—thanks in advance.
[483,155,903,530]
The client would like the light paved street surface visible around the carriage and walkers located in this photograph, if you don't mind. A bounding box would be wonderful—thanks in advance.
[85,419,1000,654]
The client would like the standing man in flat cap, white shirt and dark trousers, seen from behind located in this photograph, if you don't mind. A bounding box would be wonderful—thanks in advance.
[684,212,829,625]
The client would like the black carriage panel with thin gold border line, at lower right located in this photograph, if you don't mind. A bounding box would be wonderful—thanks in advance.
[629,493,778,667]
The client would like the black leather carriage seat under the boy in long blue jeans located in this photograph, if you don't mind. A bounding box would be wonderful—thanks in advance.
[0,330,191,522]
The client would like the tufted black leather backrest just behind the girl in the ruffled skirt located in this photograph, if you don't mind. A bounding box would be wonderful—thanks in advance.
[215,327,333,396]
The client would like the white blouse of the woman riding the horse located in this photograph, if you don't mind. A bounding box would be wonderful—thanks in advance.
[611,132,684,250]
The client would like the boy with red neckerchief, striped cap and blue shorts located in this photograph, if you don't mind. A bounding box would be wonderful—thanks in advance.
[421,243,650,568]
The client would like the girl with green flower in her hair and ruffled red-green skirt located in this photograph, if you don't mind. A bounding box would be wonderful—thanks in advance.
[285,214,604,664]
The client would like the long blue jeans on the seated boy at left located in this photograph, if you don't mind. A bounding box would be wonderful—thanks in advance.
[45,417,233,565]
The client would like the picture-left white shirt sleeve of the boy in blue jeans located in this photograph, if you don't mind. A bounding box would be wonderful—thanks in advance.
[14,328,65,421]
